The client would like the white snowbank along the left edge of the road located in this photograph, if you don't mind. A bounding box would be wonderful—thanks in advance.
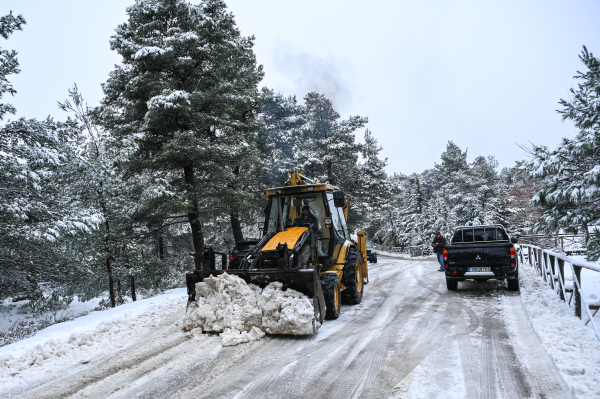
[0,288,187,390]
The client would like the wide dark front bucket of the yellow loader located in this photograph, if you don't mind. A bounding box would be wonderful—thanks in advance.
[186,268,325,324]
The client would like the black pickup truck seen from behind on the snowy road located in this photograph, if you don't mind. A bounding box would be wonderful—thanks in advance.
[444,225,519,291]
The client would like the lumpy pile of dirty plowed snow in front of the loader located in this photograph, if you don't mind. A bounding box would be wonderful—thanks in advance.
[184,273,320,346]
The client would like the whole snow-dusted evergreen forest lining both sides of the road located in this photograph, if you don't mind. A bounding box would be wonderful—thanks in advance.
[0,0,600,322]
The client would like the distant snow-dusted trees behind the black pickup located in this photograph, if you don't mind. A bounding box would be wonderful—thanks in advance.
[369,141,512,252]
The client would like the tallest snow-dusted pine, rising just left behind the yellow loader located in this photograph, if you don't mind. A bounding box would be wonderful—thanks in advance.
[100,0,263,267]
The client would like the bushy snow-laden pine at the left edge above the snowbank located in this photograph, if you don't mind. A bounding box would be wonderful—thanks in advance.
[0,119,89,300]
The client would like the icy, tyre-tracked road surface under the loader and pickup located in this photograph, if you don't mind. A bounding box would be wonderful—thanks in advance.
[0,256,597,399]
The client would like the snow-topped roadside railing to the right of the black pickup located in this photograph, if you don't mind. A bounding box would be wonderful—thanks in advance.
[519,244,600,340]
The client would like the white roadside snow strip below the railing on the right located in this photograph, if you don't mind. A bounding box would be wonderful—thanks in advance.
[516,265,600,398]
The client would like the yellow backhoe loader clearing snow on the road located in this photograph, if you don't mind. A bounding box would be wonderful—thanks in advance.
[186,169,369,323]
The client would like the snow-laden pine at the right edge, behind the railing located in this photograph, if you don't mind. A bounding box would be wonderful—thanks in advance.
[528,47,600,260]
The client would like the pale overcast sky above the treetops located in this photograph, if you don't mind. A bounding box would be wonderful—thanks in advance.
[0,0,600,174]
